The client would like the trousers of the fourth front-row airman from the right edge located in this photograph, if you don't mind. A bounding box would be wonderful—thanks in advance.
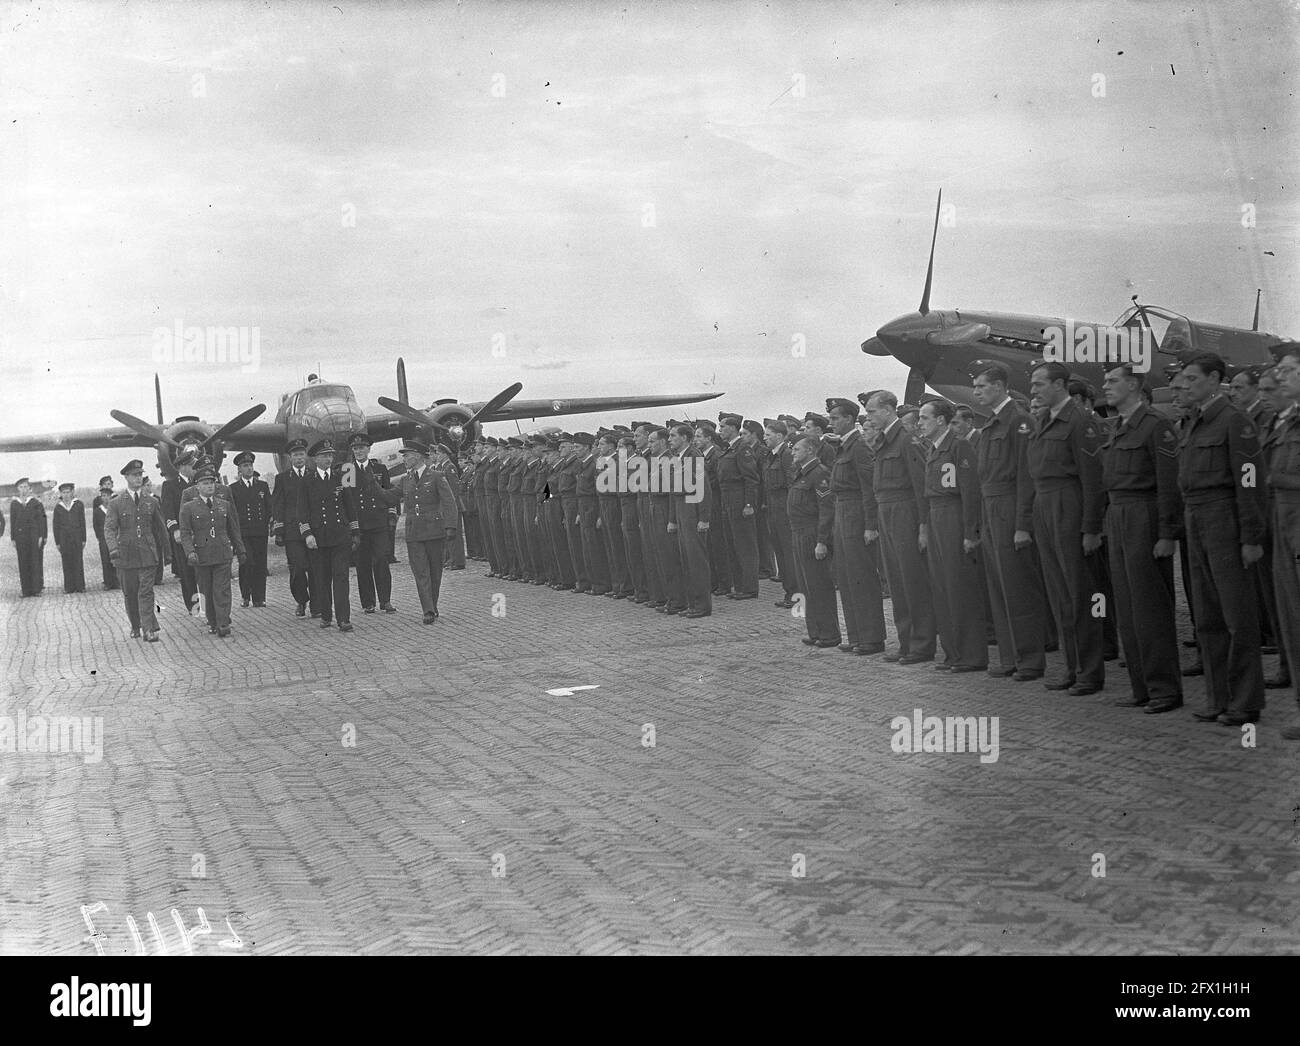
[1034,483,1114,686]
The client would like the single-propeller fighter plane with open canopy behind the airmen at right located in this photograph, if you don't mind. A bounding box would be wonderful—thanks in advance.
[862,190,1282,407]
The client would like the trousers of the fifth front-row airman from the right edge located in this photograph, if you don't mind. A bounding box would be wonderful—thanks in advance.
[980,494,1047,676]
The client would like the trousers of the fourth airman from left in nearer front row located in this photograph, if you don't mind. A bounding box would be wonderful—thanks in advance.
[927,498,988,668]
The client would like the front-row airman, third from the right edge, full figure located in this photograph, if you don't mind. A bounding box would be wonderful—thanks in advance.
[1102,364,1183,713]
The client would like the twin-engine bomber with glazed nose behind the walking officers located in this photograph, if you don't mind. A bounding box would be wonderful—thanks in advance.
[0,360,722,474]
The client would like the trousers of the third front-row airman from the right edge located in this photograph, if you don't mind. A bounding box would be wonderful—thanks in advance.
[1106,492,1183,702]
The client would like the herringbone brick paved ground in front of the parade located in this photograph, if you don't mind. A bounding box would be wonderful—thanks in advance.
[0,542,1300,955]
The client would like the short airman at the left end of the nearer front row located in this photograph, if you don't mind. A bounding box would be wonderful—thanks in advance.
[785,433,840,647]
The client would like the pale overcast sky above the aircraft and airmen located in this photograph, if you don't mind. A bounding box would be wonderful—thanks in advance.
[0,0,1300,483]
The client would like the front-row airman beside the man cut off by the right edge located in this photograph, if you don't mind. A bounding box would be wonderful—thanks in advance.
[1178,353,1265,726]
